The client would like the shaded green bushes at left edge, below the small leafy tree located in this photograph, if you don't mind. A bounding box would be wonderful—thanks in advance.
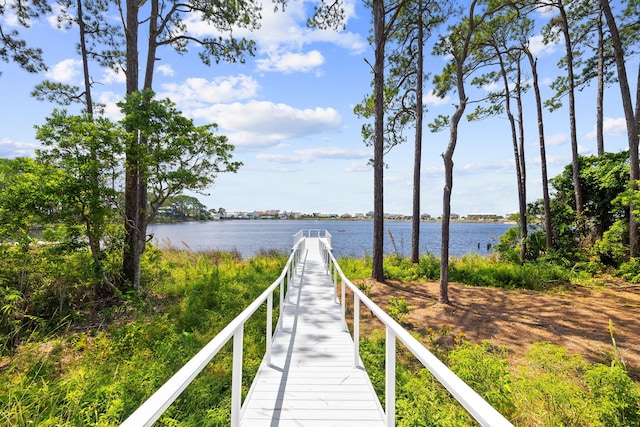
[0,243,118,353]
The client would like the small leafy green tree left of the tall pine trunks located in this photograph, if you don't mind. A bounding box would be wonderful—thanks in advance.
[36,110,125,290]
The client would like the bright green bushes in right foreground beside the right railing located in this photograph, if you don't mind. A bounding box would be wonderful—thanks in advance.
[360,335,640,427]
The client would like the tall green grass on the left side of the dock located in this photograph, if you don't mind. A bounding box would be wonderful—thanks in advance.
[0,251,286,426]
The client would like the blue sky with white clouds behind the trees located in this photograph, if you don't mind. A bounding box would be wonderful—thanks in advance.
[0,1,638,216]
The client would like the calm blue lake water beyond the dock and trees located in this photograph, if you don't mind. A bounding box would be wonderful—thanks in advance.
[149,220,511,258]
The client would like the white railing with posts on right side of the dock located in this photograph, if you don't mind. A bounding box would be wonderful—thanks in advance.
[320,239,512,427]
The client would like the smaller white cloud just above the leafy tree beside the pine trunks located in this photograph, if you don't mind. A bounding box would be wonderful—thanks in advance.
[158,74,259,109]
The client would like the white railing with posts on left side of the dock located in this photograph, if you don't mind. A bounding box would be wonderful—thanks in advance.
[121,232,304,427]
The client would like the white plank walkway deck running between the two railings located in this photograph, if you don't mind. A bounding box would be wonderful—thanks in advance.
[240,238,385,427]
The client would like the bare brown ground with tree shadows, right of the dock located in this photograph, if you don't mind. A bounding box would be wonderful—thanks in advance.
[360,282,640,380]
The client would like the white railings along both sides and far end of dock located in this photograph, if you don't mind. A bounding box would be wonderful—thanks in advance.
[121,230,512,427]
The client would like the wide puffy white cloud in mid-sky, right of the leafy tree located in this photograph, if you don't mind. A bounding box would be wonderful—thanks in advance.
[190,101,341,146]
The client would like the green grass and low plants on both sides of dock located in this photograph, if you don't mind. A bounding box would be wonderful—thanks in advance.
[0,250,640,426]
